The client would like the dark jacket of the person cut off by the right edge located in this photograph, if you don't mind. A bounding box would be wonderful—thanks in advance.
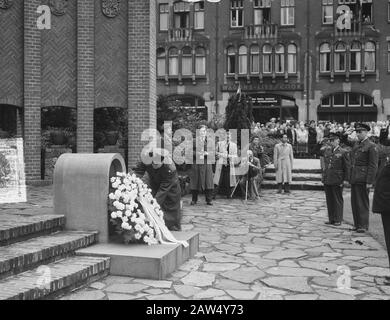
[372,163,390,215]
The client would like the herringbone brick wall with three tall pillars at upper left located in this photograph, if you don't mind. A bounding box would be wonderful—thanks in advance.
[0,0,156,181]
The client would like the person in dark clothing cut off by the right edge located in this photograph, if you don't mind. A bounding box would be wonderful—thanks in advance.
[372,157,390,286]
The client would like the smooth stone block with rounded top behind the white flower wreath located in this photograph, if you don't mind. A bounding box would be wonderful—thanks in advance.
[54,154,126,243]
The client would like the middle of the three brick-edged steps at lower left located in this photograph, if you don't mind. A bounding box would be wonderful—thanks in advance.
[0,231,98,279]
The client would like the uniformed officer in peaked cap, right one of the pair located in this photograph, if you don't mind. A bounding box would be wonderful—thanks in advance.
[350,123,379,233]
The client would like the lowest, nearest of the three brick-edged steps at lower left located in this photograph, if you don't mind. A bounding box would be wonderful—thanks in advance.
[0,257,110,300]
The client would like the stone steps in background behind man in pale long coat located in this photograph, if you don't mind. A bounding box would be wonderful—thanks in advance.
[263,159,324,190]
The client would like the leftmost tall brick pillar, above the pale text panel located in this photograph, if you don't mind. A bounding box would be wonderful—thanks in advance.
[24,0,42,181]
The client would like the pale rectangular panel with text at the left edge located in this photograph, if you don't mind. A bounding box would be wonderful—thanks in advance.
[0,138,27,203]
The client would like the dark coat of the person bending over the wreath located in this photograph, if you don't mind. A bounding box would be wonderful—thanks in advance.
[134,162,181,228]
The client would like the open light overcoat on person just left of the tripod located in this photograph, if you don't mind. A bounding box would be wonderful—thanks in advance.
[214,141,238,187]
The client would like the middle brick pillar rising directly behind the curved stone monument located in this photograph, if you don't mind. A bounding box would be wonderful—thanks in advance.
[77,0,95,153]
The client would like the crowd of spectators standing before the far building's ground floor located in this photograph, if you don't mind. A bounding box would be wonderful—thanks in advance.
[251,119,390,158]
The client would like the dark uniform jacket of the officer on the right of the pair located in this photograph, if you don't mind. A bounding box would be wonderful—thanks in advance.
[350,139,379,184]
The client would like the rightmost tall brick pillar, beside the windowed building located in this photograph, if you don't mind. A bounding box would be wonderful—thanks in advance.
[128,0,157,168]
